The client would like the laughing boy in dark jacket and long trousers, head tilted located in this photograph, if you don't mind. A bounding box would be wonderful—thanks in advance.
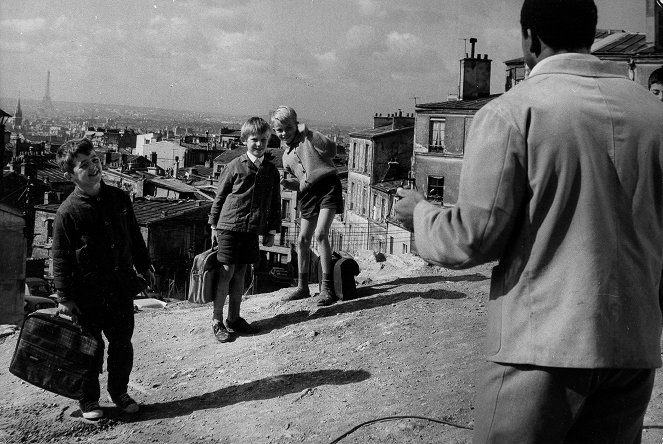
[53,139,154,419]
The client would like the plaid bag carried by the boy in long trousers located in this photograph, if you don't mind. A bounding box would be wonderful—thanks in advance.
[9,311,104,400]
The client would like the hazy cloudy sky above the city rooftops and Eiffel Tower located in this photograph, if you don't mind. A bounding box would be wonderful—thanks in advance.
[0,0,645,125]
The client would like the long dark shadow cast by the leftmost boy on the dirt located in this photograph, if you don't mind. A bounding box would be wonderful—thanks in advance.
[118,369,371,422]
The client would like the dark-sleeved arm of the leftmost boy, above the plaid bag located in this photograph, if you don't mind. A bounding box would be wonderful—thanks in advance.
[53,213,76,302]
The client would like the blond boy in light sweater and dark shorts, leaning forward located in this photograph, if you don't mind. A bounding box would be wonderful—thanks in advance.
[272,106,343,306]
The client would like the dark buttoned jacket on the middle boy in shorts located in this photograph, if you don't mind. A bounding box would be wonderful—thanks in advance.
[208,153,281,235]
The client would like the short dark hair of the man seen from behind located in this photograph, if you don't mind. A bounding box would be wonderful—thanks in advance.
[520,0,598,51]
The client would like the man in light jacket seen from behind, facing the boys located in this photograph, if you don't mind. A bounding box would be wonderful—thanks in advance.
[396,0,663,443]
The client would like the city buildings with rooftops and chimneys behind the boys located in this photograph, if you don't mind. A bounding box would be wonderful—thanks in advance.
[0,0,663,326]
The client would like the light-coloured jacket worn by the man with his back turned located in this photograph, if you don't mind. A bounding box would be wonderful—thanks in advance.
[414,54,663,368]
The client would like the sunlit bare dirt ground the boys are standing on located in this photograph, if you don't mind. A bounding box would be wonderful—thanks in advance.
[0,255,663,444]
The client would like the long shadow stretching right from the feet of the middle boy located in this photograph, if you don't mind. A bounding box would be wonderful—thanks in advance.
[253,284,467,335]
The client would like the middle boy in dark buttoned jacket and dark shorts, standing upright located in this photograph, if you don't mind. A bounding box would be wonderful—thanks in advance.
[209,117,281,342]
